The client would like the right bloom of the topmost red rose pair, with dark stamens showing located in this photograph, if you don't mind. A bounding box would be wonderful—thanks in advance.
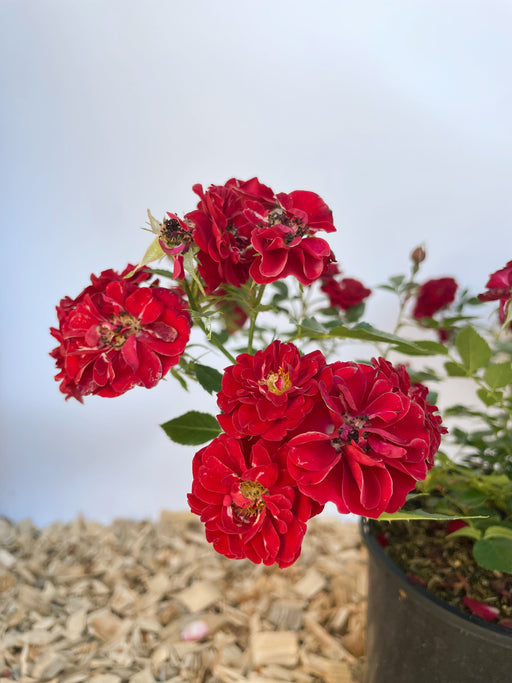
[250,190,336,285]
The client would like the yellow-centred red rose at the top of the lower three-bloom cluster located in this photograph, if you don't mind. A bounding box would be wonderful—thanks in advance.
[217,341,325,441]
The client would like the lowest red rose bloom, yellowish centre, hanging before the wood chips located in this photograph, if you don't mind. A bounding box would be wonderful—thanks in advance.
[188,434,323,567]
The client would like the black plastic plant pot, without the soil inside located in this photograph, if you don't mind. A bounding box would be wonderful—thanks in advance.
[361,520,512,683]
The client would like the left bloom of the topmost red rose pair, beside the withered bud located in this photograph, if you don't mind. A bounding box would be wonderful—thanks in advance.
[185,178,275,292]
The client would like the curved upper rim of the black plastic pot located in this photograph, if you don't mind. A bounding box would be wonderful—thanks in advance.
[360,517,512,646]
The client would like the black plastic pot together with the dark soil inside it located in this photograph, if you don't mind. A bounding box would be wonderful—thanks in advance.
[362,520,512,683]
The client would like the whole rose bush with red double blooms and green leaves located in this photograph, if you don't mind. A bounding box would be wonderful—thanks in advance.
[51,178,512,584]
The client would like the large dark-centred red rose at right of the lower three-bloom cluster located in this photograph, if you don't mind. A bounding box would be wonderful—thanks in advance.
[288,359,442,517]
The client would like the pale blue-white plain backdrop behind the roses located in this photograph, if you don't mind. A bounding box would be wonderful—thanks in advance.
[0,0,512,524]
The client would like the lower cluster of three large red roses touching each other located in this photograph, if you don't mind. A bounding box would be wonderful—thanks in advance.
[188,341,446,567]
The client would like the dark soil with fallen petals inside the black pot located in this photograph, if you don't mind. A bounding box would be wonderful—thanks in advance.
[373,521,512,632]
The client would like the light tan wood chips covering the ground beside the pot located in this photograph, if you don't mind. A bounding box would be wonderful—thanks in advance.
[0,511,367,683]
